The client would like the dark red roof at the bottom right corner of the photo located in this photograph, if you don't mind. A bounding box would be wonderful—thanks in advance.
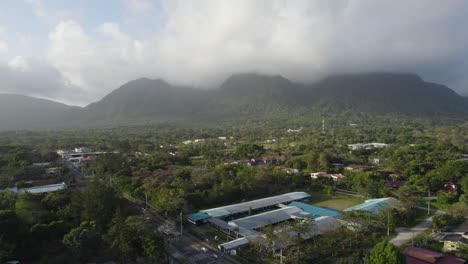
[403,247,465,264]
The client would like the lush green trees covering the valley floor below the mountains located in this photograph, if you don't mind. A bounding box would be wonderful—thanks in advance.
[0,114,468,263]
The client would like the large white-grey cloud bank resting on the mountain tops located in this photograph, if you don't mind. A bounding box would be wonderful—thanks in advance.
[40,0,468,104]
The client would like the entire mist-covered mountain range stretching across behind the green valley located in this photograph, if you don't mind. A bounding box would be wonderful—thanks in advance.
[0,73,468,130]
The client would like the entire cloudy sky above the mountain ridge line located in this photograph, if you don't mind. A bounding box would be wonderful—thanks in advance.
[0,0,468,106]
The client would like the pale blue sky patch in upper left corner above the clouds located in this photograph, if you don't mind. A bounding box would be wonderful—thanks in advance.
[0,0,163,59]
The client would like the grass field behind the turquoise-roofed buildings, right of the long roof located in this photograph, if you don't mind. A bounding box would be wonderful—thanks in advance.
[309,192,365,210]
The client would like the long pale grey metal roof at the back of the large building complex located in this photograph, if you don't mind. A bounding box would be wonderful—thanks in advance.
[200,192,310,217]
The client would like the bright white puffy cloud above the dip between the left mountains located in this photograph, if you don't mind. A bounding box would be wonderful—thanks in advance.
[47,21,148,97]
